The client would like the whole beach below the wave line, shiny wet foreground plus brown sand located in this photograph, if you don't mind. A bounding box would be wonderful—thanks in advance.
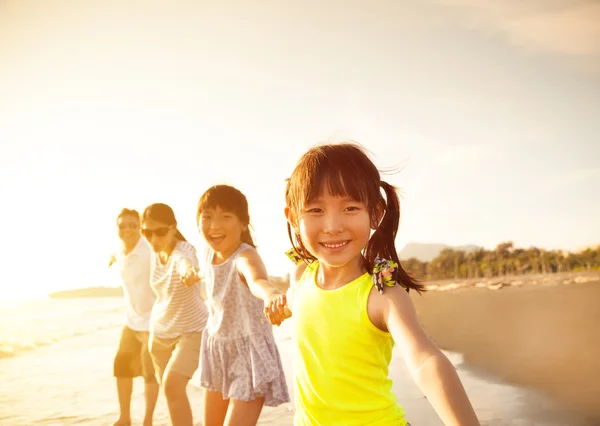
[0,272,600,426]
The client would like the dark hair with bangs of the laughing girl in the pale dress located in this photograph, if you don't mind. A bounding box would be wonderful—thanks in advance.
[196,185,256,247]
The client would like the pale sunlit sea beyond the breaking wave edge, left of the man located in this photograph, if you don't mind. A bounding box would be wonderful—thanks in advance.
[0,298,125,358]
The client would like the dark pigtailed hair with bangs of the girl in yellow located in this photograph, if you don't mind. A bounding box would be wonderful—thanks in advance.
[285,143,425,292]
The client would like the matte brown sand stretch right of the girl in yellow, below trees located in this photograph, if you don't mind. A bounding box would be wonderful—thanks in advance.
[413,272,600,424]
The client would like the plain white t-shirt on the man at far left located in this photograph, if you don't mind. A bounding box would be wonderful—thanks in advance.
[115,237,156,331]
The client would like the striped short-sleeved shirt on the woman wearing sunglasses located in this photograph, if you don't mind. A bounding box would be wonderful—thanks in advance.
[150,241,208,339]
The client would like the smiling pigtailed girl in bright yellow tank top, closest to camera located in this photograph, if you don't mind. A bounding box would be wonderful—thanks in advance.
[265,143,479,426]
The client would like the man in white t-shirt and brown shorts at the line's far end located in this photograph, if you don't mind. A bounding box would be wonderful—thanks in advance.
[109,209,159,426]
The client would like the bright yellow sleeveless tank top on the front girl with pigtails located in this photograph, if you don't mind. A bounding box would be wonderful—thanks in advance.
[292,262,406,426]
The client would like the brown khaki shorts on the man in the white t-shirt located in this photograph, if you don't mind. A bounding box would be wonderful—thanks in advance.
[114,326,156,383]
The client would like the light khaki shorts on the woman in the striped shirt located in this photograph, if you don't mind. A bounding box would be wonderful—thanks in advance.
[150,332,202,382]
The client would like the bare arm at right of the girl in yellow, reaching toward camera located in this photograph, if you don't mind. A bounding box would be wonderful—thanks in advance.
[378,286,479,426]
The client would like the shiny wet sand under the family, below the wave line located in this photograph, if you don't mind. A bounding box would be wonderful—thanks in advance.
[0,295,597,426]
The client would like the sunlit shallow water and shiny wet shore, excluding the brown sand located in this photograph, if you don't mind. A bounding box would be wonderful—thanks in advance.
[0,298,598,426]
